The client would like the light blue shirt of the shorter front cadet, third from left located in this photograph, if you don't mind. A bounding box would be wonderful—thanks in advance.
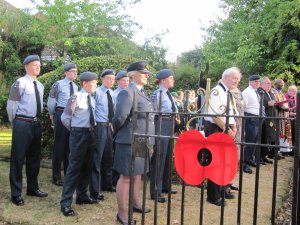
[61,88,96,130]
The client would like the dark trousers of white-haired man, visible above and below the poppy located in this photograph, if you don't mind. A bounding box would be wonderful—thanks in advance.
[204,121,222,201]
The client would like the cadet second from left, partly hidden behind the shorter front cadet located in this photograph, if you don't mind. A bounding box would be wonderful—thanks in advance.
[47,63,78,186]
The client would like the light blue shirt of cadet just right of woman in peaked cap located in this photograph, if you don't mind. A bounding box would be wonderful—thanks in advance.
[152,86,173,113]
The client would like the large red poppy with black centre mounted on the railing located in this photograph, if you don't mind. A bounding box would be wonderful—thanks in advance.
[174,130,238,186]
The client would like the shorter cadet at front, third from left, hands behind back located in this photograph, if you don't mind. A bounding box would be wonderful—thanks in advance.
[60,72,97,216]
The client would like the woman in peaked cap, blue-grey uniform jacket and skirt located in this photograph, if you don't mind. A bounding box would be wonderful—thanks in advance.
[113,61,154,224]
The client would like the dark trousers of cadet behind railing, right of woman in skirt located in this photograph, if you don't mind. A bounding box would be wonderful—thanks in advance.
[150,120,172,195]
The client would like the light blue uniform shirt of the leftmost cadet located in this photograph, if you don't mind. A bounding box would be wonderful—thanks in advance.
[6,74,44,122]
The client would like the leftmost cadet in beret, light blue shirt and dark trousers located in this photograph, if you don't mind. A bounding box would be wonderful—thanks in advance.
[6,55,48,206]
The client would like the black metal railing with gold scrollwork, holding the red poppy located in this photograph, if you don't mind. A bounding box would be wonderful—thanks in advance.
[129,92,300,225]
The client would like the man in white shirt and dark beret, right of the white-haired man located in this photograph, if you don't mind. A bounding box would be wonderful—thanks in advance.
[242,75,260,174]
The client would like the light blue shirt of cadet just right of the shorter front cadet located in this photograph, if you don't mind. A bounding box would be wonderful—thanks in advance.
[95,85,115,122]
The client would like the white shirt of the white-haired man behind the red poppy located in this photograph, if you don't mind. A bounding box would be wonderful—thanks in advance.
[205,83,239,125]
